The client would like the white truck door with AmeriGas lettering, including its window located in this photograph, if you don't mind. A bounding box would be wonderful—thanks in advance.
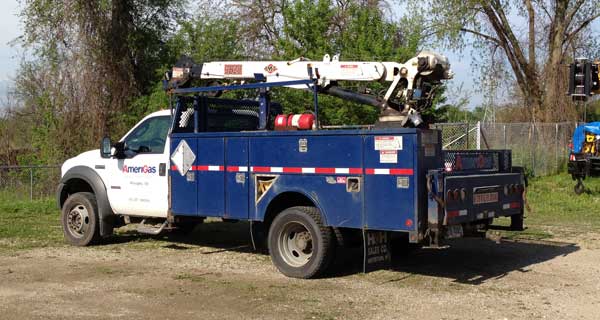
[106,115,171,217]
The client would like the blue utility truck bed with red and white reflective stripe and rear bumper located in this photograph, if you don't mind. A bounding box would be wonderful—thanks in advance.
[171,128,524,242]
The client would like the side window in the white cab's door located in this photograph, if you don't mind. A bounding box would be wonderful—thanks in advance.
[123,116,171,153]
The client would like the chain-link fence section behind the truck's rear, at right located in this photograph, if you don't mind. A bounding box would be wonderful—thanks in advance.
[433,122,577,176]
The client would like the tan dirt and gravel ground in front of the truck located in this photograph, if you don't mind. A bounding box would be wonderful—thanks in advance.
[0,222,600,319]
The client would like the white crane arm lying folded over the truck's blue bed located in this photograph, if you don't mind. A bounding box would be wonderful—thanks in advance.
[167,51,453,126]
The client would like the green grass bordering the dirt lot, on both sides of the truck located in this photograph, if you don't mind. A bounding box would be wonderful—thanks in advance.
[0,174,600,251]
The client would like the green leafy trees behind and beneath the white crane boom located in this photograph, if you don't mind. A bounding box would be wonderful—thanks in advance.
[224,0,421,124]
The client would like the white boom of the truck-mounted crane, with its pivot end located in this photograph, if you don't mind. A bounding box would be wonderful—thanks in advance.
[172,51,453,124]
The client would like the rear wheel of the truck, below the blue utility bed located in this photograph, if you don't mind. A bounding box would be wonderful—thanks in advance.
[268,207,335,279]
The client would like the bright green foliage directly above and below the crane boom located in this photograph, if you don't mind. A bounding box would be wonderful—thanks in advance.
[273,0,420,125]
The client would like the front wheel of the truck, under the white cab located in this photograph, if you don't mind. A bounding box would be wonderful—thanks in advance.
[60,192,101,247]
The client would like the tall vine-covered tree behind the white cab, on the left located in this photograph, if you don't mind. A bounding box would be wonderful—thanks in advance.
[14,0,184,162]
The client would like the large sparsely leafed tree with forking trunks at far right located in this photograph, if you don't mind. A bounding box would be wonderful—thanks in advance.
[409,0,600,121]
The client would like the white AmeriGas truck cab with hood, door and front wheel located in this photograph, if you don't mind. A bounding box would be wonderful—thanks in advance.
[58,110,171,245]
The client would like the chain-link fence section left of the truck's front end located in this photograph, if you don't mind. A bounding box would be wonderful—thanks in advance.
[0,165,60,200]
